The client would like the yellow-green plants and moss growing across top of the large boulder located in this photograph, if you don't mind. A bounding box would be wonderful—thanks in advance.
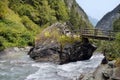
[36,28,81,46]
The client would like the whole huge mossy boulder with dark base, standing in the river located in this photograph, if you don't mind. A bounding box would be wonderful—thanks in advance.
[28,23,96,64]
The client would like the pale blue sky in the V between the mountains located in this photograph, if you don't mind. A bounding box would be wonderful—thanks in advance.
[76,0,120,20]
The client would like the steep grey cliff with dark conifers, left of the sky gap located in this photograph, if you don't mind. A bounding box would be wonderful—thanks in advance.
[64,0,92,29]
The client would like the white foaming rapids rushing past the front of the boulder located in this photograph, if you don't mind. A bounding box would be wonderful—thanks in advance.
[25,54,103,80]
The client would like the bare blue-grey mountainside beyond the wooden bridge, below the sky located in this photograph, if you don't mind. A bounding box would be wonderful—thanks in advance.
[96,5,120,30]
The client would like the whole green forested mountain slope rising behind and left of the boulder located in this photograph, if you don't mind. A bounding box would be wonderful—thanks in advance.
[0,0,91,49]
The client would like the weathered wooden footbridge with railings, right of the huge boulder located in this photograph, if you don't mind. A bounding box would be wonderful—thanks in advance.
[76,28,115,41]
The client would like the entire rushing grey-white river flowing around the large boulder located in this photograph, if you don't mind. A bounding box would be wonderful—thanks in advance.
[0,52,103,80]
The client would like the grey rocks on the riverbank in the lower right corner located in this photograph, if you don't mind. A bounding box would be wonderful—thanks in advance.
[79,61,120,80]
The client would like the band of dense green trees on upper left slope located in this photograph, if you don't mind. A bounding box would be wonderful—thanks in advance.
[9,0,69,26]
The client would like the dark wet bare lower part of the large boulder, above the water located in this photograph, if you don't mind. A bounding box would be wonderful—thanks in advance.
[28,42,96,64]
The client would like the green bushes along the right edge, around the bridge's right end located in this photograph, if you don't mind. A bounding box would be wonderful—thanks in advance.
[96,18,120,60]
